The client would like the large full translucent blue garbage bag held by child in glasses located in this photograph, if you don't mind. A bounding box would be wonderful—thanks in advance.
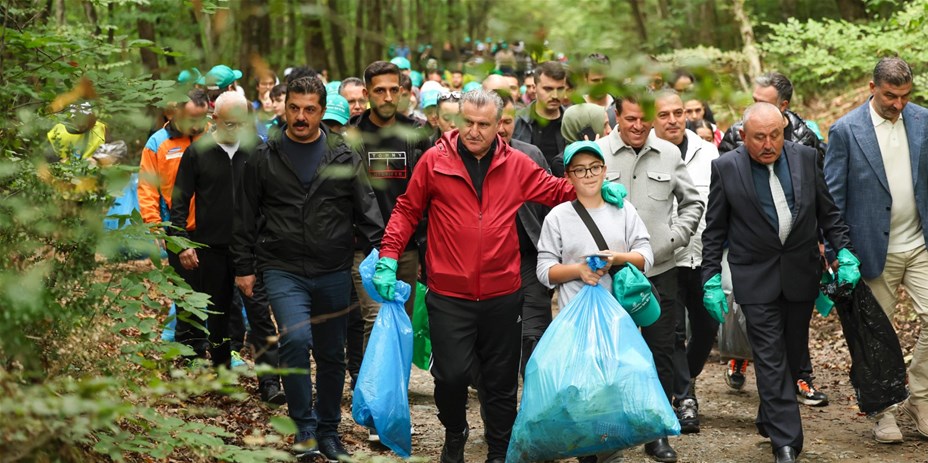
[506,262,680,463]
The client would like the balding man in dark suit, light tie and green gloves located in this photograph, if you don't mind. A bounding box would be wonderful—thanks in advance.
[702,103,859,463]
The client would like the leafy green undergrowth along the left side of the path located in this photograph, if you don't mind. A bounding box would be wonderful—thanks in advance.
[0,2,292,462]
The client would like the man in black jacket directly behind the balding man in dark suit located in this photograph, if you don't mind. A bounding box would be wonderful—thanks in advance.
[719,72,827,162]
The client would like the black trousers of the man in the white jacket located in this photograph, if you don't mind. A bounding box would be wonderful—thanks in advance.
[673,267,719,401]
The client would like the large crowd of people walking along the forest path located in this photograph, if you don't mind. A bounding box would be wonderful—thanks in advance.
[125,50,928,463]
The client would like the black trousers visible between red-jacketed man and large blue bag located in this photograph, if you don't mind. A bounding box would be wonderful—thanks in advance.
[519,252,551,375]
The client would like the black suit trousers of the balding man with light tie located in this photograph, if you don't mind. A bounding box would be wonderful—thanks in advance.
[741,296,812,451]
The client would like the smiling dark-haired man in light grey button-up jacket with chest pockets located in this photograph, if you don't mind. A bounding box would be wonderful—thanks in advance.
[596,96,704,462]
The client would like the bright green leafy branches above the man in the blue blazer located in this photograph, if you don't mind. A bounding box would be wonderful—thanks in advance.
[761,0,928,101]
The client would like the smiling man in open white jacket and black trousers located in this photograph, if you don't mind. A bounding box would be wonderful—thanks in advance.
[654,90,719,433]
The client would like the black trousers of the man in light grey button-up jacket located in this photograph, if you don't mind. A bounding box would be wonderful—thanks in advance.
[641,268,677,401]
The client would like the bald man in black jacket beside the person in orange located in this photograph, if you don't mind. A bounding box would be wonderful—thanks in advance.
[171,92,286,405]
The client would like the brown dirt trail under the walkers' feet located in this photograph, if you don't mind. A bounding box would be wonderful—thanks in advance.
[342,315,928,463]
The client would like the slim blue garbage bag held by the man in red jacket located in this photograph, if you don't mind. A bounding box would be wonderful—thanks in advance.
[351,249,412,458]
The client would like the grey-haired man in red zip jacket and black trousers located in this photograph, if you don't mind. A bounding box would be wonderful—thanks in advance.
[374,89,624,463]
